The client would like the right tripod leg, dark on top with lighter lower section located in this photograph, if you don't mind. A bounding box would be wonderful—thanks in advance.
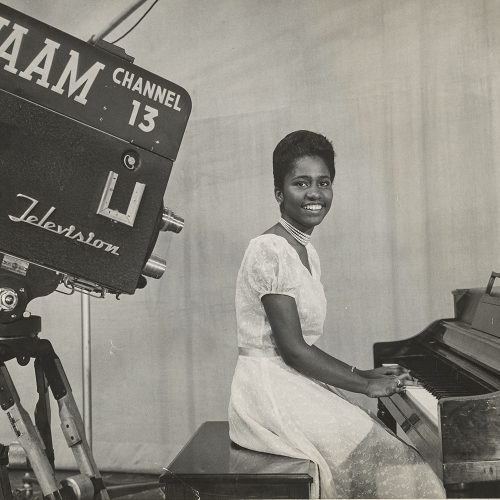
[42,352,109,500]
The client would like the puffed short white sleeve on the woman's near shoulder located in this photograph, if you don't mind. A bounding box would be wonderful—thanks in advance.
[242,234,299,299]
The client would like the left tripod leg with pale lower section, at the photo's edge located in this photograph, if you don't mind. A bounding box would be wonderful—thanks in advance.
[0,363,62,500]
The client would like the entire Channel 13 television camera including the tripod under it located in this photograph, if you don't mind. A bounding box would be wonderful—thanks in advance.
[0,4,191,500]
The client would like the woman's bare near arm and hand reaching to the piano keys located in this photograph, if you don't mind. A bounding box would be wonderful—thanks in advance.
[261,294,413,397]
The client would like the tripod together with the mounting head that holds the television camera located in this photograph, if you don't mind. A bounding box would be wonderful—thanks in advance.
[0,266,110,500]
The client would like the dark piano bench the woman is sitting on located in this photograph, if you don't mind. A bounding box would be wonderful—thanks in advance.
[160,422,314,500]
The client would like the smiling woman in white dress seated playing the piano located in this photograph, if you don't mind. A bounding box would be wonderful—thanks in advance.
[229,130,445,498]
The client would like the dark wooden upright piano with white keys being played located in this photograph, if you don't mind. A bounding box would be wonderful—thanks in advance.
[373,273,500,498]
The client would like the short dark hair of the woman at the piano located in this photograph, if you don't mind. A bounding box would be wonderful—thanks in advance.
[273,130,335,189]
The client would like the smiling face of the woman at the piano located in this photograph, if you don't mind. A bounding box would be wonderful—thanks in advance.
[275,156,333,234]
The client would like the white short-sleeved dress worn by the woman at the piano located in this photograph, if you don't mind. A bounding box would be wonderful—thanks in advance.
[229,234,446,498]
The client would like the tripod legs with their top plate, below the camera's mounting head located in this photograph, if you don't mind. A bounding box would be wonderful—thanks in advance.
[0,316,109,500]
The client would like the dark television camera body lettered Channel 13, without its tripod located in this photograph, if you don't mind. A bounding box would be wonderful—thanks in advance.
[0,4,191,294]
